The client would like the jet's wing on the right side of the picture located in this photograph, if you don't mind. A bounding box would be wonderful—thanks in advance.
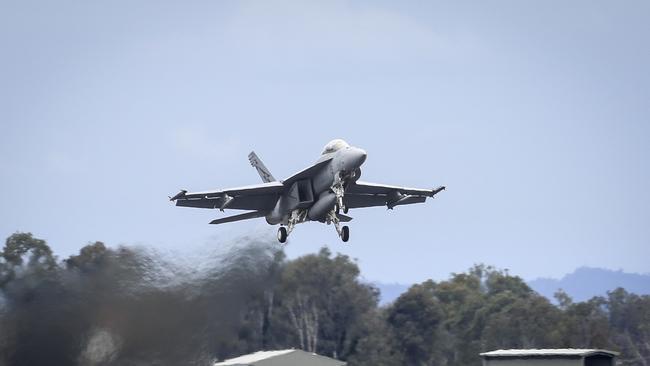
[343,181,445,209]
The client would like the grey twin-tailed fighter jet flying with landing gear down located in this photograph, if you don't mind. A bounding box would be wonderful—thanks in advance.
[169,139,445,243]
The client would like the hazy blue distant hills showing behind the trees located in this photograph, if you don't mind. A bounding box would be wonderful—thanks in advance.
[374,267,650,305]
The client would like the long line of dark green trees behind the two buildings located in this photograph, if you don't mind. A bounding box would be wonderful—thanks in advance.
[0,233,650,366]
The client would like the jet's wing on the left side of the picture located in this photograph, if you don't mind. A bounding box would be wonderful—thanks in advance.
[170,182,284,212]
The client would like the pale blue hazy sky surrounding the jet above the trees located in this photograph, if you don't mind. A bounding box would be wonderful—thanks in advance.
[0,0,650,283]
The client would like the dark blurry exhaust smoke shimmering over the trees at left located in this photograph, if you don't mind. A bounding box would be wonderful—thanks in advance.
[0,234,281,366]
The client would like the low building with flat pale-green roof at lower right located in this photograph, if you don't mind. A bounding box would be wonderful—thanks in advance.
[481,348,618,366]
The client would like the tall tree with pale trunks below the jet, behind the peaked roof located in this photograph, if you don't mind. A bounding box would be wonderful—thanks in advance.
[280,248,378,359]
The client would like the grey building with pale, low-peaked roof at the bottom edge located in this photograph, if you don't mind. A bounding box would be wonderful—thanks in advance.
[214,349,345,366]
